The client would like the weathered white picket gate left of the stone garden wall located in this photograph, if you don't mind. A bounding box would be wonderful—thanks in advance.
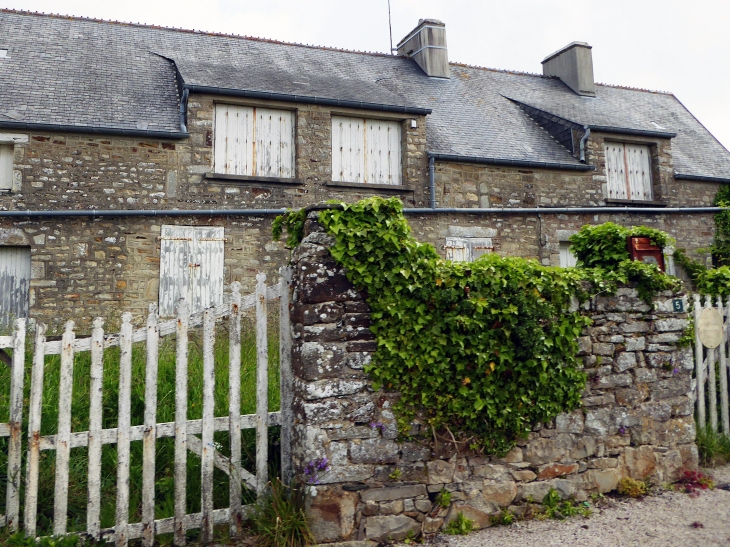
[0,268,292,546]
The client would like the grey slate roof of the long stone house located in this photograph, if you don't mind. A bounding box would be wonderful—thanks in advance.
[0,10,730,179]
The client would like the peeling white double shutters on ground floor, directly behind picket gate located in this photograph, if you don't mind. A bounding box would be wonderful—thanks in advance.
[159,226,225,315]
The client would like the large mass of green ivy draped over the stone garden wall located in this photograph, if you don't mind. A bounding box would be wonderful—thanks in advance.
[276,197,684,453]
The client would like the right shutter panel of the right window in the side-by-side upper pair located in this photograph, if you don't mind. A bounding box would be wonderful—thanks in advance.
[365,120,401,184]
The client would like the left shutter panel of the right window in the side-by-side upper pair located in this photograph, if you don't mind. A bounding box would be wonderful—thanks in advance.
[332,116,365,182]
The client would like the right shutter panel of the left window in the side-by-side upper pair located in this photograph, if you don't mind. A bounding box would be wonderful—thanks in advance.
[255,108,294,178]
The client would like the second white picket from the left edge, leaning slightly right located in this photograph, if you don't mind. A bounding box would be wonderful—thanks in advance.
[23,323,46,537]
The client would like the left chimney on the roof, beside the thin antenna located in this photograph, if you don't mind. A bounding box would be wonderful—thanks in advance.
[397,19,449,78]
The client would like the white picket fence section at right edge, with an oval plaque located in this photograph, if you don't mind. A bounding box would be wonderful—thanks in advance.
[692,294,730,435]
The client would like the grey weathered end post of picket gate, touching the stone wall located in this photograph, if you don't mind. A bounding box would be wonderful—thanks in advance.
[279,266,293,485]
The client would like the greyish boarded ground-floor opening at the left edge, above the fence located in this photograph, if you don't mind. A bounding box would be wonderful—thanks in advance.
[0,247,30,327]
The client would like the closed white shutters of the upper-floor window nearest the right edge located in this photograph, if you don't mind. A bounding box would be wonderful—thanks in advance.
[604,142,653,201]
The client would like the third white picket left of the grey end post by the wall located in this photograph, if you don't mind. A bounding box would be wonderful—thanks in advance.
[200,308,215,545]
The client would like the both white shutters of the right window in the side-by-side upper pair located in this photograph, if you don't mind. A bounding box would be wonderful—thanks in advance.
[332,116,401,184]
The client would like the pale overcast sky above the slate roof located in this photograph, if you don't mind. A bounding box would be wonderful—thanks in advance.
[5,0,730,148]
